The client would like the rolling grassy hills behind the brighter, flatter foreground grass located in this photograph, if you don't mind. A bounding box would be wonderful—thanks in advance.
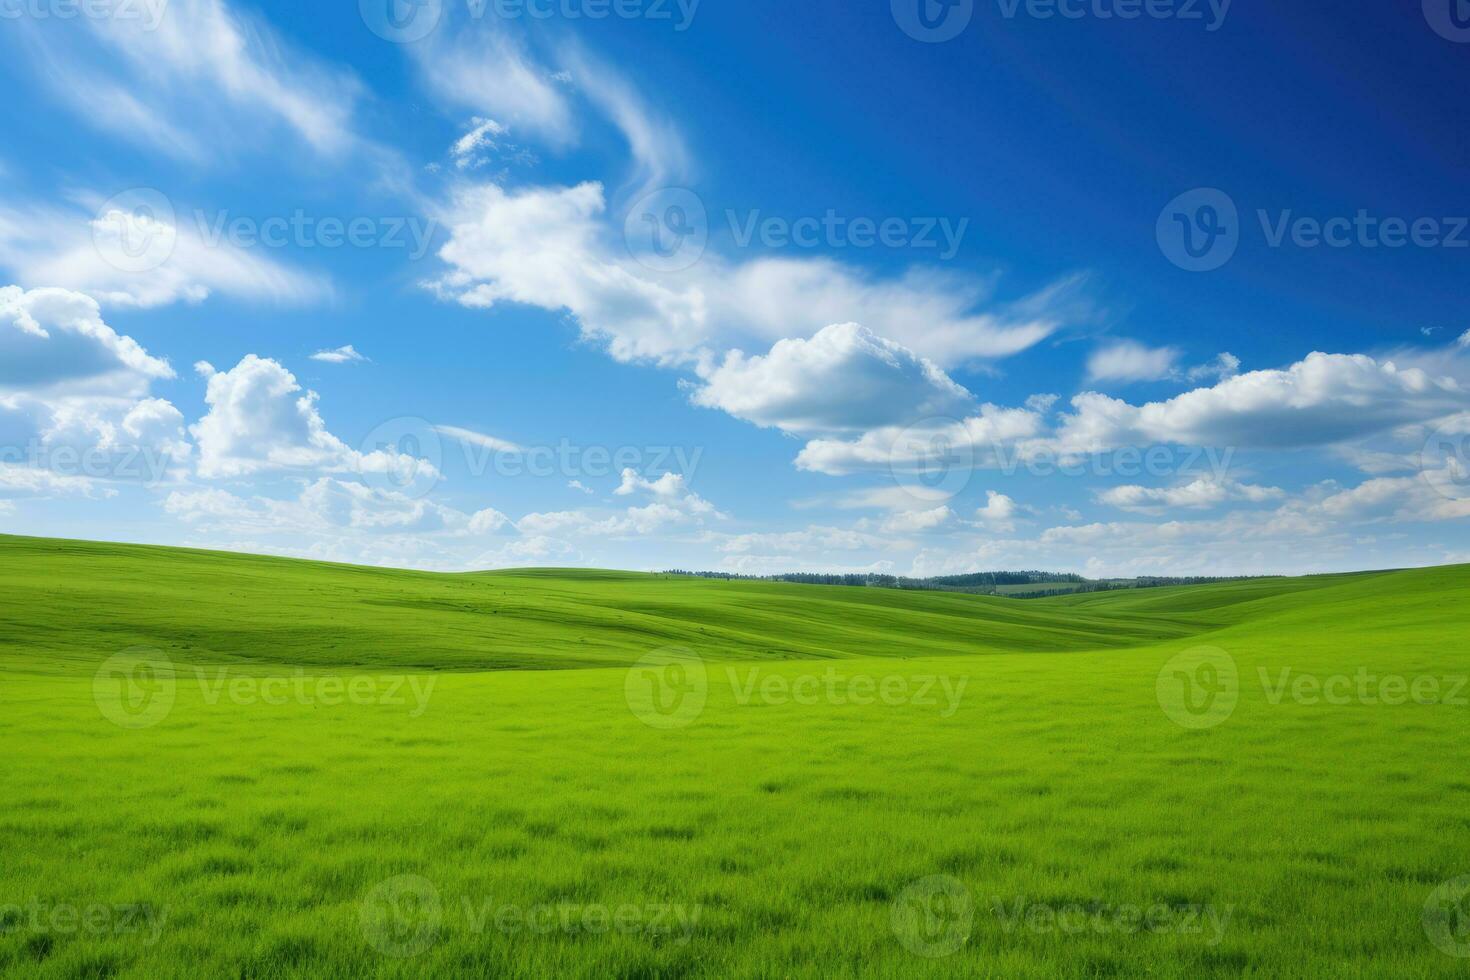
[0,536,1452,670]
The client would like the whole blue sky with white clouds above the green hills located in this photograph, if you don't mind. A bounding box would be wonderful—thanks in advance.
[0,0,1470,576]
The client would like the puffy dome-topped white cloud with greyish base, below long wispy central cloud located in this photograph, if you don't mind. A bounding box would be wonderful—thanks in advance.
[692,323,973,432]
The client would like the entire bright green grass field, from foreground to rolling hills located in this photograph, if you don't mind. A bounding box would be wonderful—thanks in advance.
[0,538,1470,977]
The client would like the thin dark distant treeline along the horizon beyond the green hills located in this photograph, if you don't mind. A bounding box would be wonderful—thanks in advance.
[663,569,1280,599]
